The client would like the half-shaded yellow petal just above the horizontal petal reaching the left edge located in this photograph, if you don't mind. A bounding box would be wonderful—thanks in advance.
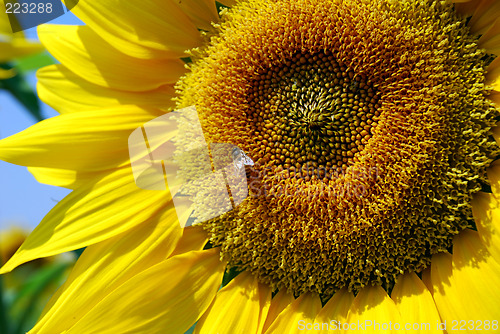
[37,65,175,114]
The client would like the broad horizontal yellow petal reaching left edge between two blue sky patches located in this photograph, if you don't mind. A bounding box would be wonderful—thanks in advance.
[0,106,163,171]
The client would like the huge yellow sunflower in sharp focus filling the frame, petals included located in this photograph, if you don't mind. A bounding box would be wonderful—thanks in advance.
[0,0,500,334]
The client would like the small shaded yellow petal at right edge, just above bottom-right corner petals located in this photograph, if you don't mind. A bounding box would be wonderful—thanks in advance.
[472,192,500,262]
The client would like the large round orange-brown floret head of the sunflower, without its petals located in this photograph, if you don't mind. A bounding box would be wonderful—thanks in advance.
[177,0,499,297]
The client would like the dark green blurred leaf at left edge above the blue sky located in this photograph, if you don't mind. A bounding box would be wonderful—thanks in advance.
[0,64,43,122]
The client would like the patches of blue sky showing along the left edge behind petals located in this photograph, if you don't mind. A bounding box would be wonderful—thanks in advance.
[0,12,82,230]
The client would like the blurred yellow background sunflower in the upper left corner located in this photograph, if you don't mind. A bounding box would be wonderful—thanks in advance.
[0,11,43,79]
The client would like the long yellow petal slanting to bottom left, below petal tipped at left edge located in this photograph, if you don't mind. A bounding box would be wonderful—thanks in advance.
[32,206,181,333]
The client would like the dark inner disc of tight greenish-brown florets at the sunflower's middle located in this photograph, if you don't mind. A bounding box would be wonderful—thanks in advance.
[248,51,380,176]
